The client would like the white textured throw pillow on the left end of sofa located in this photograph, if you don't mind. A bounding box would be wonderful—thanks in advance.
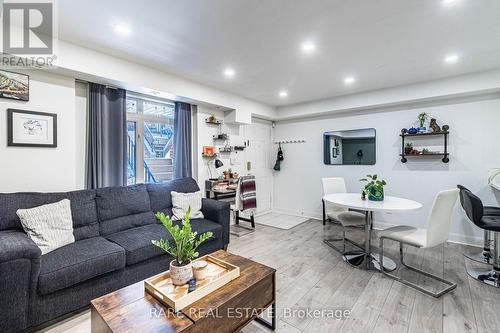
[16,199,75,255]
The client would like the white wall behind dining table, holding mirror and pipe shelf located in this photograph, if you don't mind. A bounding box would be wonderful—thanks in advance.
[274,99,500,244]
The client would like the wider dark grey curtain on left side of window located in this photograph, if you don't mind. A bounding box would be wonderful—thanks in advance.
[86,83,127,189]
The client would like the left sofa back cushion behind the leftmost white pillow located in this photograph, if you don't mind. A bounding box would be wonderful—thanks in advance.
[0,190,99,240]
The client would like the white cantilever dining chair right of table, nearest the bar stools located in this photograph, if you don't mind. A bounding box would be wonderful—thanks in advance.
[379,189,459,297]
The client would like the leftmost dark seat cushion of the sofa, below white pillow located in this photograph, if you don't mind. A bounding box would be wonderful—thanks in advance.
[38,237,125,295]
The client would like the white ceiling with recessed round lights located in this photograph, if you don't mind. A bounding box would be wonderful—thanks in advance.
[58,0,500,105]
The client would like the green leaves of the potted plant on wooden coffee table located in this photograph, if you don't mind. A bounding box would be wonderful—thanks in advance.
[152,208,213,266]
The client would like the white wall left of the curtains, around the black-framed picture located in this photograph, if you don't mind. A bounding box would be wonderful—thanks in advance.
[0,70,85,192]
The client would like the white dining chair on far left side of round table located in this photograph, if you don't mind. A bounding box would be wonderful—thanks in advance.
[322,177,366,253]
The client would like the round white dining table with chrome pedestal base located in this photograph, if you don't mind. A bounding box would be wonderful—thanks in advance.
[323,193,422,271]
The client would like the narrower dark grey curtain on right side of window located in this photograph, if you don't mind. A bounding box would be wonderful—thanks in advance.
[174,102,192,179]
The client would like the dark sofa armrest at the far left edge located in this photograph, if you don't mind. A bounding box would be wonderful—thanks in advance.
[0,231,42,332]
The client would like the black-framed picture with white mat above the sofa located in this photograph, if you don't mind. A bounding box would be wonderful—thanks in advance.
[7,109,57,148]
